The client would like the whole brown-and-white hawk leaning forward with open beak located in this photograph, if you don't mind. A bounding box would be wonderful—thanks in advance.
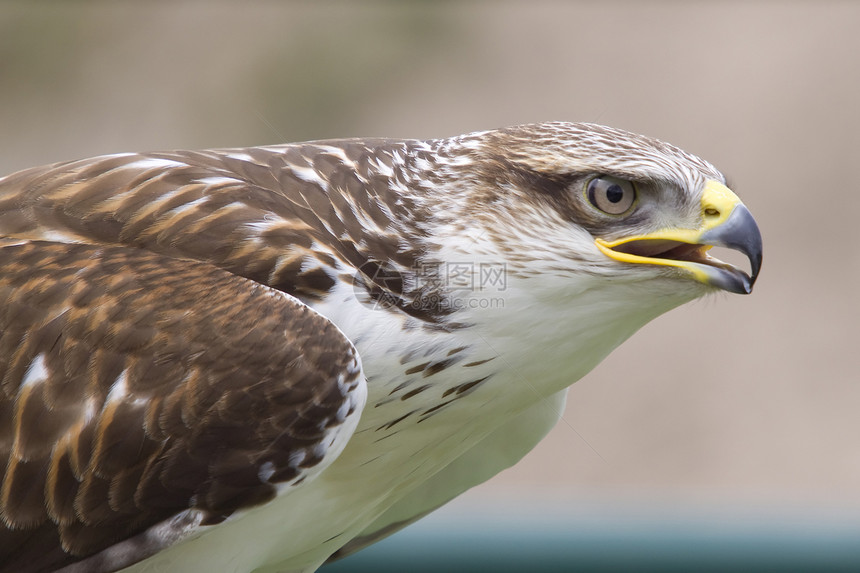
[0,122,762,573]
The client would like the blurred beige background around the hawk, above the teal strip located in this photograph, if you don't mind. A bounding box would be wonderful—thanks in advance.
[0,1,860,508]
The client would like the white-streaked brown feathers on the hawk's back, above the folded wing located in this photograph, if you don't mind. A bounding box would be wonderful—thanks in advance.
[0,144,416,299]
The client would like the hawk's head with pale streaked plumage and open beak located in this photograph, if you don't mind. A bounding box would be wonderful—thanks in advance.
[420,123,762,303]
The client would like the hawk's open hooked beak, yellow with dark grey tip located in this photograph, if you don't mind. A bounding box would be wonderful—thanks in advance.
[594,180,762,294]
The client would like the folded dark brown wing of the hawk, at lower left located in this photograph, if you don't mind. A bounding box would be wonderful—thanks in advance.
[0,240,360,571]
